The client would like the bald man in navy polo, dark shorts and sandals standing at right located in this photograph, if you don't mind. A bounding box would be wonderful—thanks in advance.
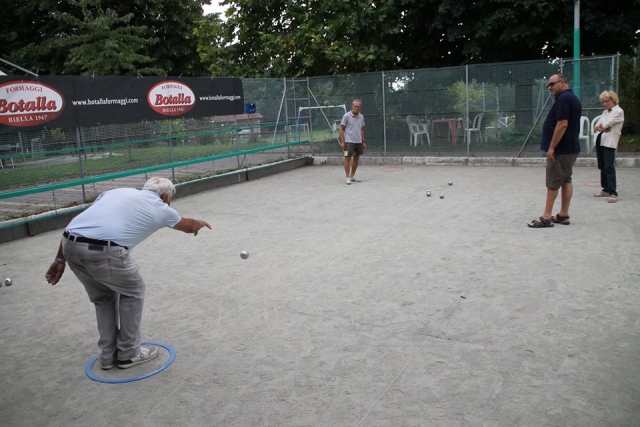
[527,74,582,228]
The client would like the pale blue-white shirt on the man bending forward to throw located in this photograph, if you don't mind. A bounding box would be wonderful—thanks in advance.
[66,188,182,249]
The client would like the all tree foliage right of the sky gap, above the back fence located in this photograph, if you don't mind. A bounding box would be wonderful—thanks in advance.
[199,0,640,77]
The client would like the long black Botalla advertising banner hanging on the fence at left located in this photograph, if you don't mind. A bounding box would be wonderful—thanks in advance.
[0,76,245,133]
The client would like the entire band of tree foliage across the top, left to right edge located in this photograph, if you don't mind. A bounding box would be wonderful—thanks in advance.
[0,0,640,77]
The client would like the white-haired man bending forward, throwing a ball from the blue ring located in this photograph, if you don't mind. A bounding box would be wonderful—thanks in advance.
[45,177,211,370]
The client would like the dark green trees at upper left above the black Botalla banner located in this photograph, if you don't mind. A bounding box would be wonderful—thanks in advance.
[0,0,210,76]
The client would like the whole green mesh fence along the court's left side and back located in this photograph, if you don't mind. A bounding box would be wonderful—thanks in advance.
[0,56,619,221]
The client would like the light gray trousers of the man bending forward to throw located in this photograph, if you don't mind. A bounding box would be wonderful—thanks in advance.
[62,237,146,366]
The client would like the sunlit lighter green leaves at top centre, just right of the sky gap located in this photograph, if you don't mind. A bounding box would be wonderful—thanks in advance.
[199,0,398,77]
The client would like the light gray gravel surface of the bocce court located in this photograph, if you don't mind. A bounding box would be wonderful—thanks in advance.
[0,165,640,426]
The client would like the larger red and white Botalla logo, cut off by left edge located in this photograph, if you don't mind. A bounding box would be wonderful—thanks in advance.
[0,81,64,126]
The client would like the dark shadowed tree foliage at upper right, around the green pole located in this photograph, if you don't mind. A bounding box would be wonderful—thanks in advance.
[409,0,640,67]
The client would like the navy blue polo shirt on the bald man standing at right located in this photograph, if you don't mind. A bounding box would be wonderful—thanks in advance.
[540,89,582,154]
